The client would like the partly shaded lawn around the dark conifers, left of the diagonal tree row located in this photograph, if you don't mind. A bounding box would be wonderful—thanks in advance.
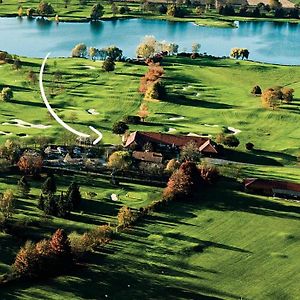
[0,174,161,274]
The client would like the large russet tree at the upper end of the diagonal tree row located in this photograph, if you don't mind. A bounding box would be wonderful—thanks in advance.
[163,162,203,200]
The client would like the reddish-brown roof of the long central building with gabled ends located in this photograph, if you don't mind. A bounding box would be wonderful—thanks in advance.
[125,131,218,153]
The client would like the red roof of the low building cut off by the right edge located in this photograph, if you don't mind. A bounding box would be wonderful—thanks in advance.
[244,178,300,192]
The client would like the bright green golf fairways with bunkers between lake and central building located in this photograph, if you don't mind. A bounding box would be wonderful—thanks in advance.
[0,57,300,164]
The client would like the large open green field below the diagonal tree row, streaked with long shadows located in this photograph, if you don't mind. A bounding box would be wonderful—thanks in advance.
[2,180,300,299]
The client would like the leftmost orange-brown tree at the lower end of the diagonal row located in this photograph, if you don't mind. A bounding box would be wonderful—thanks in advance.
[12,241,38,278]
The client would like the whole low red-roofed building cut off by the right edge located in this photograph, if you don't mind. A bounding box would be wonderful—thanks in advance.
[244,178,300,200]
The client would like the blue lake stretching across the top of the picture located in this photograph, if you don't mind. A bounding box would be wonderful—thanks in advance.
[0,18,300,65]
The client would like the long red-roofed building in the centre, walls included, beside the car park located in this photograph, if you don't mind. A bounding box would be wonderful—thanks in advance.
[125,131,218,155]
